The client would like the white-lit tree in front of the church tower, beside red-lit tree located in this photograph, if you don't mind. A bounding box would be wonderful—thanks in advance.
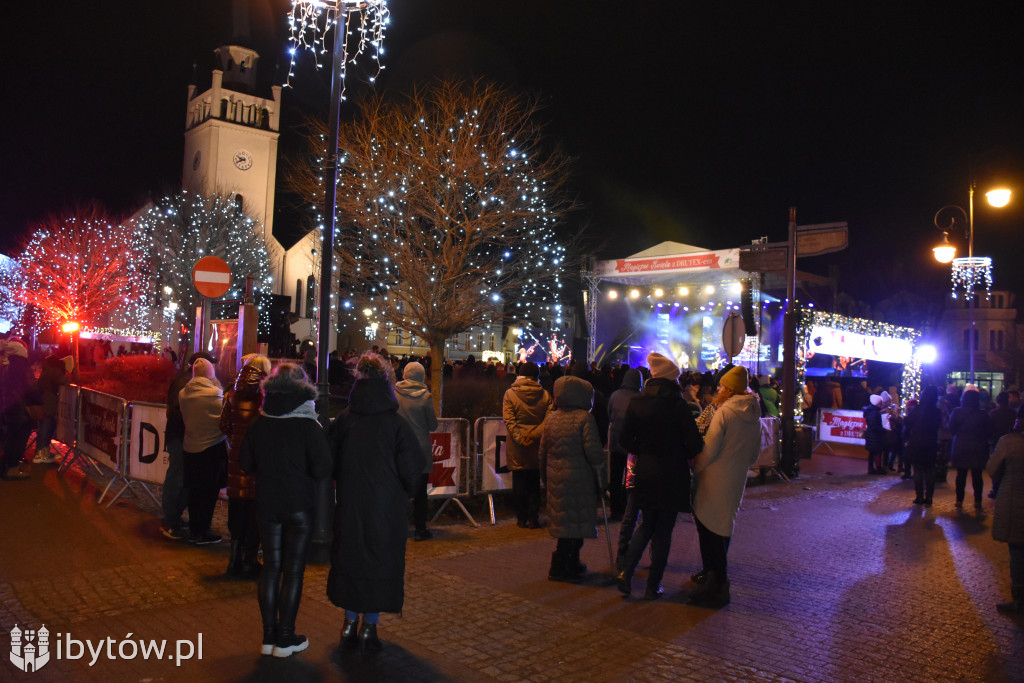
[133,190,271,352]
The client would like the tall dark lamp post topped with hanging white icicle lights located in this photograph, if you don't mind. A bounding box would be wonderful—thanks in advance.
[288,0,390,425]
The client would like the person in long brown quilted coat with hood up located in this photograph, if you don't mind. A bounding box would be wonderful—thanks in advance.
[538,376,607,583]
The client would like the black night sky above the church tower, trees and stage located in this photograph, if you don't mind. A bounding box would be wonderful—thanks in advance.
[0,0,1024,303]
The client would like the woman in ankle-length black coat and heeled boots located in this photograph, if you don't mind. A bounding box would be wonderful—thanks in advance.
[327,351,423,651]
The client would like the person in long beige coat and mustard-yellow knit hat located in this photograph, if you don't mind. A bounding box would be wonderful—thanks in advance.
[689,366,761,607]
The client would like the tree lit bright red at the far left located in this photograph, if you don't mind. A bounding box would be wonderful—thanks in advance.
[8,208,150,329]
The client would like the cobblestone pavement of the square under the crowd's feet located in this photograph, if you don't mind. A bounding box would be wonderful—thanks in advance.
[0,446,1024,682]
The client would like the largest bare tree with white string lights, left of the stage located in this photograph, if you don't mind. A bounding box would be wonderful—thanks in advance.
[289,82,574,402]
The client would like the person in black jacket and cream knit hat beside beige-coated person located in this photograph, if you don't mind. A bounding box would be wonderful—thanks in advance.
[616,351,703,600]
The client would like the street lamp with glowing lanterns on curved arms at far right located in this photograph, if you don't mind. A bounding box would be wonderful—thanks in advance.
[932,184,1011,384]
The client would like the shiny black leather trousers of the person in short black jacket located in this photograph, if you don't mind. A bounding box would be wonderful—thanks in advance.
[257,510,313,637]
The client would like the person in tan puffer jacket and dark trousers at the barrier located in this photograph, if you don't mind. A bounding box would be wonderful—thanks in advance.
[502,361,551,528]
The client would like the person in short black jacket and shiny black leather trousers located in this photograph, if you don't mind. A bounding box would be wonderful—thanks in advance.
[240,362,332,657]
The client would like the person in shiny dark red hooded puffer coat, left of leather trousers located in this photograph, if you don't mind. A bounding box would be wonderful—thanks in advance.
[220,353,270,579]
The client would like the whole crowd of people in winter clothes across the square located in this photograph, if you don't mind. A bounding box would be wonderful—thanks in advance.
[6,327,1024,657]
